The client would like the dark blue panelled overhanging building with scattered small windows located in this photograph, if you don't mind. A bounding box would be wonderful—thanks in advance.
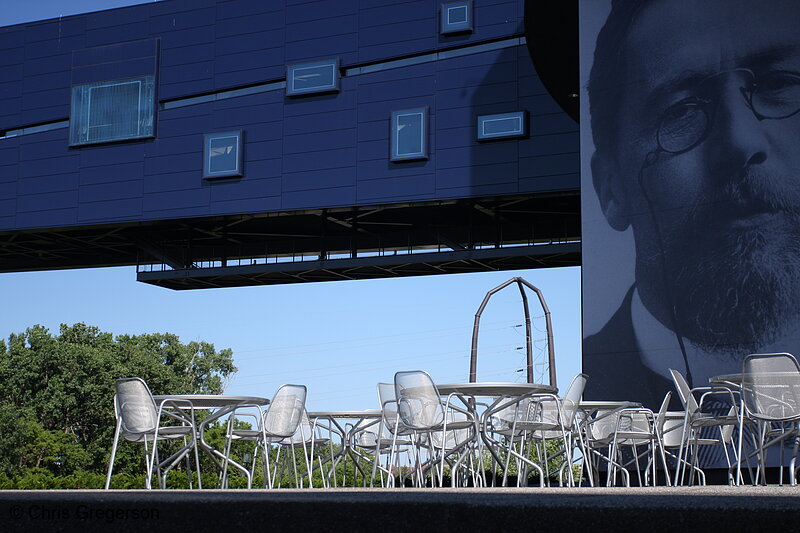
[0,0,579,288]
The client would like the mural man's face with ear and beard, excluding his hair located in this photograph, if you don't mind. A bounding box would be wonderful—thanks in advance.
[592,0,800,356]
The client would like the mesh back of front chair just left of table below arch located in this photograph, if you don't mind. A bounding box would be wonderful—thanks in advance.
[394,370,444,431]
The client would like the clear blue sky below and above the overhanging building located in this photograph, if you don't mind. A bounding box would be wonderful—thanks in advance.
[0,0,581,409]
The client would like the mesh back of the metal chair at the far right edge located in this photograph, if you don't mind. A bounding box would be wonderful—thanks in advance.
[742,353,800,421]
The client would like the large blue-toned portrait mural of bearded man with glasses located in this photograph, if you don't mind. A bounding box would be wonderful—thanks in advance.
[580,0,800,408]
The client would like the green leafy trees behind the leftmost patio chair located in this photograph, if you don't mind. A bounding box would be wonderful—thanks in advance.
[0,323,236,477]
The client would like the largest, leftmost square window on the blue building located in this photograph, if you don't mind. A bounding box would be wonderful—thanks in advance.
[69,76,155,146]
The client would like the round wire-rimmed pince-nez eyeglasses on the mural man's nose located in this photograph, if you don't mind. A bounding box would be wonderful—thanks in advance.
[656,69,800,154]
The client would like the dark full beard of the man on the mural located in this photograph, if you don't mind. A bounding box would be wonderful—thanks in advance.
[653,173,800,357]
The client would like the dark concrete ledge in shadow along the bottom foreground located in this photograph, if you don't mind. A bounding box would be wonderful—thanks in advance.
[0,486,800,533]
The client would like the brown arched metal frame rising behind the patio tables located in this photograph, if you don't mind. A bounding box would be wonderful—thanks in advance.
[469,277,557,387]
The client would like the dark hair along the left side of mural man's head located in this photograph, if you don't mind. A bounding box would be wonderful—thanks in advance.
[587,0,652,156]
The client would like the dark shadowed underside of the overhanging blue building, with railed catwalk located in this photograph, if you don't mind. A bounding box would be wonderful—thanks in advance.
[0,191,580,289]
